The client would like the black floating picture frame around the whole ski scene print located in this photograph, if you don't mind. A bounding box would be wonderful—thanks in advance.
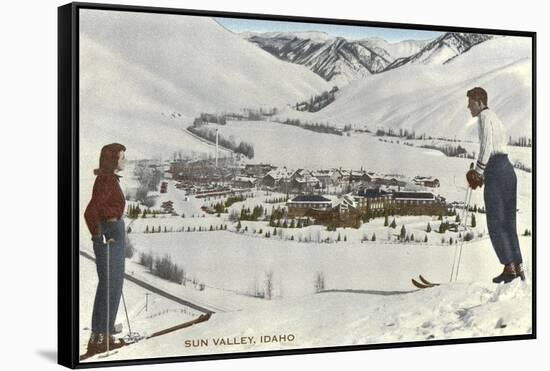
[58,2,537,368]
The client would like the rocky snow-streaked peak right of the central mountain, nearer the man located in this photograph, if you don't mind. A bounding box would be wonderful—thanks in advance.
[385,32,491,71]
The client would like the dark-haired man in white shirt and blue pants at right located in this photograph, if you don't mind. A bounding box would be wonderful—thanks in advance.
[466,87,525,283]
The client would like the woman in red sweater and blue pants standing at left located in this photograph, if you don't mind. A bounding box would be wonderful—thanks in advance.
[84,143,126,355]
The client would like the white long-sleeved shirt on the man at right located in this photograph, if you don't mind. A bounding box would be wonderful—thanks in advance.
[475,108,508,175]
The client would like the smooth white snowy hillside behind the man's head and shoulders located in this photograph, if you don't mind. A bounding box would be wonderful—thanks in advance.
[280,37,532,139]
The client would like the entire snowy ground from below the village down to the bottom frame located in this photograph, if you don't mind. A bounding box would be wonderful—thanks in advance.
[81,217,532,361]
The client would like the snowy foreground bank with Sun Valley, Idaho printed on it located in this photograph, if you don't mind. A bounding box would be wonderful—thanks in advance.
[106,282,531,360]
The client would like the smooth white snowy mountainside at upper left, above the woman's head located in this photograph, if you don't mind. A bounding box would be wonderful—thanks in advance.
[80,10,330,168]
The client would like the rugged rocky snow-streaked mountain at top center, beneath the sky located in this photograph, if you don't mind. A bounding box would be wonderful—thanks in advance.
[241,32,394,87]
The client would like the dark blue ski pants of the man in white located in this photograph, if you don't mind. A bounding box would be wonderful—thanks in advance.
[483,155,523,264]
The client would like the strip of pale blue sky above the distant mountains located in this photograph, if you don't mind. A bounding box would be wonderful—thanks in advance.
[214,17,442,43]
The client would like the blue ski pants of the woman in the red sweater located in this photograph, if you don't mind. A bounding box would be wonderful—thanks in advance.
[92,219,125,334]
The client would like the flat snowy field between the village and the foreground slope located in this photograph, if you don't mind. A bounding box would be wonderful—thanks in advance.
[131,231,530,298]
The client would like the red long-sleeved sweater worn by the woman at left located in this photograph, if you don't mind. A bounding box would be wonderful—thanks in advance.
[84,173,126,236]
